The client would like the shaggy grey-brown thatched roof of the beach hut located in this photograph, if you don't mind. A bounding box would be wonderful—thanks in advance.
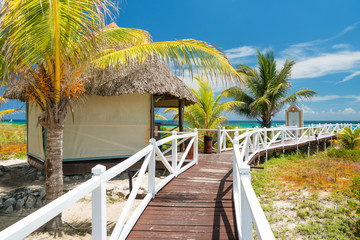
[4,60,197,105]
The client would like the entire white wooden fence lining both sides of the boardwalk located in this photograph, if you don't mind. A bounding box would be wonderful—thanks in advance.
[0,124,359,240]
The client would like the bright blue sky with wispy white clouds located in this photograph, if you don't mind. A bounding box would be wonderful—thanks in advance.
[2,0,360,120]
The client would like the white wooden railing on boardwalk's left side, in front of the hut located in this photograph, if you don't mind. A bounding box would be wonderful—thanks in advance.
[0,129,198,240]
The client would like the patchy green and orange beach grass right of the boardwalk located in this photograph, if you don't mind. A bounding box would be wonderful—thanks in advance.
[252,149,360,239]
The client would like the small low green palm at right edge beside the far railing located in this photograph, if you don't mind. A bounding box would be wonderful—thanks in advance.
[333,127,360,150]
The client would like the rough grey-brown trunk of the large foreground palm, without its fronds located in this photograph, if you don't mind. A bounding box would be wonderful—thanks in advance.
[45,126,64,231]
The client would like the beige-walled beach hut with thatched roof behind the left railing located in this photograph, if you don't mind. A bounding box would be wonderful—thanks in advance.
[4,60,196,174]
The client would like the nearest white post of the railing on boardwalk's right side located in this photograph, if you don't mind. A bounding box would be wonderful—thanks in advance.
[240,163,253,239]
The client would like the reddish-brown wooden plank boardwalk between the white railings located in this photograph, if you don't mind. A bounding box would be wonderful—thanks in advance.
[127,151,238,239]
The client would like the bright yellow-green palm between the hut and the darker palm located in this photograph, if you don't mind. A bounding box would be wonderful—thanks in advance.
[165,77,243,134]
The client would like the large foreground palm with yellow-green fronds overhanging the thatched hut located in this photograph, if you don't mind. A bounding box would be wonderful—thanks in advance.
[0,0,240,228]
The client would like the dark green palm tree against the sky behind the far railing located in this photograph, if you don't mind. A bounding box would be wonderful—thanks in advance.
[228,50,316,128]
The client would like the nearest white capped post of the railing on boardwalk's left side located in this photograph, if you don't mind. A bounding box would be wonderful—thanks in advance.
[91,164,107,240]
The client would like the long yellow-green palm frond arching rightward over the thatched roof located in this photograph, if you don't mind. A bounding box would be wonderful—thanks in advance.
[93,39,242,84]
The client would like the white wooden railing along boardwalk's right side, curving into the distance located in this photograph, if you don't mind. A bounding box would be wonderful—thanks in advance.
[232,124,352,240]
